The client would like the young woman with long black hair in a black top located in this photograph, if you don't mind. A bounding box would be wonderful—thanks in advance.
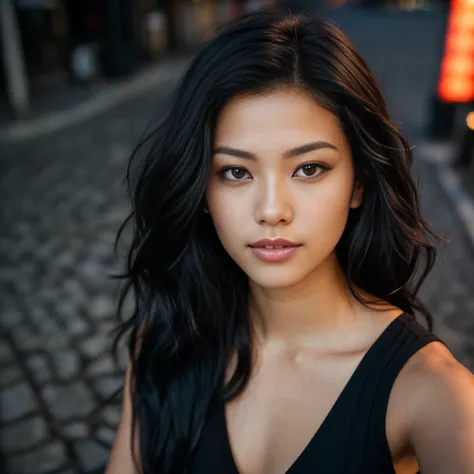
[107,7,474,474]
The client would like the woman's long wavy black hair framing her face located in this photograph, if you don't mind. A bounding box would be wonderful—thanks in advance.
[111,7,435,474]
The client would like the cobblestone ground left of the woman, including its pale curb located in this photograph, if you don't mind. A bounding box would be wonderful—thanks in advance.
[0,58,192,474]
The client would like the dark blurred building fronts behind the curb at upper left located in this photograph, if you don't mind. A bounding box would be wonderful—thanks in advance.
[1,0,272,117]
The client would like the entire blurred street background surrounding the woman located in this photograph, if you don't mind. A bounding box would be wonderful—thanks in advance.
[0,0,474,474]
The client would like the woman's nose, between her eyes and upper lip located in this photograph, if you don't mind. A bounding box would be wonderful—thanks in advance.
[255,176,293,226]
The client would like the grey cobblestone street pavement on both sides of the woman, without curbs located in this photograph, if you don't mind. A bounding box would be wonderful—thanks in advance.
[0,6,474,474]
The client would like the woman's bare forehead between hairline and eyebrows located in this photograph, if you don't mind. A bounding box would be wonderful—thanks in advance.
[215,89,347,150]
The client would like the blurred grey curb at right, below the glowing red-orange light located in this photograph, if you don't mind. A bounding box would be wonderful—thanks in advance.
[417,143,474,248]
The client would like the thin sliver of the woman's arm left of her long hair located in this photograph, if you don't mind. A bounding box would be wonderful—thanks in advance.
[105,364,139,474]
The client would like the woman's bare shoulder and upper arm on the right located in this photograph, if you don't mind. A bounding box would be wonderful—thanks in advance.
[393,342,474,474]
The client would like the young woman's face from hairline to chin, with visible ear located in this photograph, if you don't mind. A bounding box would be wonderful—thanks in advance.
[207,89,361,288]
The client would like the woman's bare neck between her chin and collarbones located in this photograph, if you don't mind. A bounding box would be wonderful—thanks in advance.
[249,255,368,343]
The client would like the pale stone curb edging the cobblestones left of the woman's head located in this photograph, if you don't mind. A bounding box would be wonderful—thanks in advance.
[0,57,190,143]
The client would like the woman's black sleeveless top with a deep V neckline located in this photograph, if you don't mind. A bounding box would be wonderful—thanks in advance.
[187,314,441,474]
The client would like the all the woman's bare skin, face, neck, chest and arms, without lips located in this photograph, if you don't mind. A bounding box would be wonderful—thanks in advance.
[106,89,474,474]
